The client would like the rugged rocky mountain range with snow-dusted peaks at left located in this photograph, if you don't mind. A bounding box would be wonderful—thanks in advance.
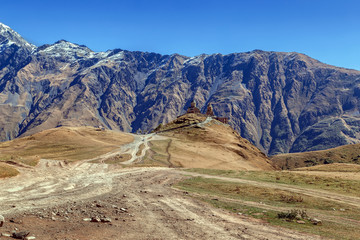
[0,24,360,155]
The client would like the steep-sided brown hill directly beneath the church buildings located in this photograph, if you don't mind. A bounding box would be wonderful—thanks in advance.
[153,113,273,170]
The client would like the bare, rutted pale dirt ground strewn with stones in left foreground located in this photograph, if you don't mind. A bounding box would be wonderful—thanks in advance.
[0,160,319,240]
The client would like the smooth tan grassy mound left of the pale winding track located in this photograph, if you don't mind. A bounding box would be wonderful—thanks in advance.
[0,127,133,165]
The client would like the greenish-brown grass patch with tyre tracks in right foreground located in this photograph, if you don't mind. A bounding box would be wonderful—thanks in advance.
[175,172,360,239]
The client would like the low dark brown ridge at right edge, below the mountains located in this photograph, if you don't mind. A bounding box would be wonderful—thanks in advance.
[271,144,360,169]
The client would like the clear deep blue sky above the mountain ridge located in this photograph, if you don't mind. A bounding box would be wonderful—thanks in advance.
[0,0,360,70]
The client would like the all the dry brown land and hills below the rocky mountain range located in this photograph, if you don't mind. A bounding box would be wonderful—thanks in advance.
[0,114,360,240]
